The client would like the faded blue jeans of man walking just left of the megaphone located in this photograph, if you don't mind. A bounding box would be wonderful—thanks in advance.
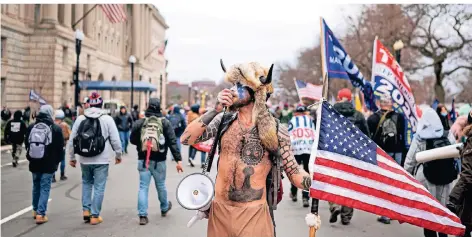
[138,160,169,216]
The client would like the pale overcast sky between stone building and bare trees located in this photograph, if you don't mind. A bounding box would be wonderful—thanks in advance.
[156,0,360,83]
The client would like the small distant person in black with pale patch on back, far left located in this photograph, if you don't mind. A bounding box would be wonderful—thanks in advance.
[3,110,27,167]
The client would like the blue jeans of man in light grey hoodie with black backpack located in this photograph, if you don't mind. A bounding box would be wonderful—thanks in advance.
[80,164,108,217]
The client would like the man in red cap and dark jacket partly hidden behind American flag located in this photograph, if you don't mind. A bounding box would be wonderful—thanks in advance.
[329,88,369,225]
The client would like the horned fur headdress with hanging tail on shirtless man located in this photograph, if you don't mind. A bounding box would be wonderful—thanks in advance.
[220,60,278,152]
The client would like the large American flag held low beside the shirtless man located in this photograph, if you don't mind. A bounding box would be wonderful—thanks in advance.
[310,101,465,236]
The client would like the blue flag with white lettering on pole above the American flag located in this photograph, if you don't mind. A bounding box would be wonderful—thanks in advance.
[321,18,377,112]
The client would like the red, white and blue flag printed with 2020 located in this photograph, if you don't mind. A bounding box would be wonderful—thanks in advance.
[372,38,420,147]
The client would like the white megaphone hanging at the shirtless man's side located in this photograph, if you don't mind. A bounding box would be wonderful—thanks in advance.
[176,173,215,227]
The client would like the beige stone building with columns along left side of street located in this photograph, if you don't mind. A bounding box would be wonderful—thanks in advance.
[1,4,168,111]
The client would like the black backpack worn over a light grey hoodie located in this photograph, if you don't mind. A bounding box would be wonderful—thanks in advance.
[73,117,108,157]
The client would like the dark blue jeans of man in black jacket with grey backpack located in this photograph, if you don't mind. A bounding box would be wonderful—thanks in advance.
[32,173,54,216]
